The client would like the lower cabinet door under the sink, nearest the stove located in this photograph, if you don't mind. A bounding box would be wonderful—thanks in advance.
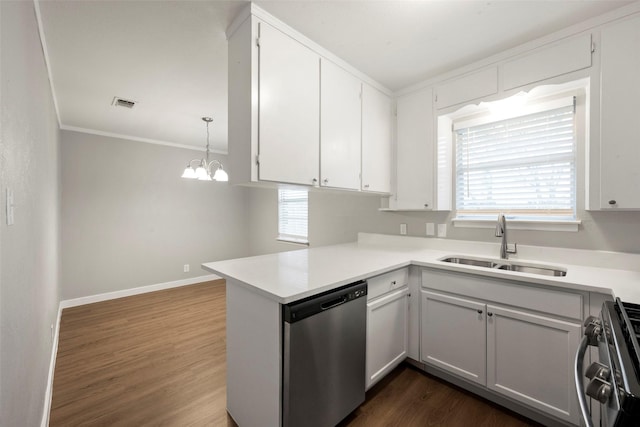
[487,305,581,424]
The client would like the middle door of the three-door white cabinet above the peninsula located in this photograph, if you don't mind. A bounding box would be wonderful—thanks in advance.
[320,59,362,190]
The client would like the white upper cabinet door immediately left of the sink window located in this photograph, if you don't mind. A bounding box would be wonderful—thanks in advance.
[395,88,436,209]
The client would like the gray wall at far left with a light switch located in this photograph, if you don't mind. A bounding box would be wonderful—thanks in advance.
[0,1,59,426]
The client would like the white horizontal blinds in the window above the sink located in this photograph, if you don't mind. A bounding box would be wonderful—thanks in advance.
[455,98,576,219]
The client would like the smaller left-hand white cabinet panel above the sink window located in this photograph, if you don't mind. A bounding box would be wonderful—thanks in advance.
[435,67,498,109]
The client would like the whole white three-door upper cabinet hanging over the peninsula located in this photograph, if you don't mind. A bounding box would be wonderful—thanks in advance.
[227,3,392,193]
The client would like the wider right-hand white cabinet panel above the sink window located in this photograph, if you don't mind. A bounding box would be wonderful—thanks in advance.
[501,34,591,90]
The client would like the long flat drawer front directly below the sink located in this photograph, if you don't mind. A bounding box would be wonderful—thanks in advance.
[422,269,583,321]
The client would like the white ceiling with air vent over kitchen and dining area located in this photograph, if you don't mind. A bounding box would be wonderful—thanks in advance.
[39,0,630,152]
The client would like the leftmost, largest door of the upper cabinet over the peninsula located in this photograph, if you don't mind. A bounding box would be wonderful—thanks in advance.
[258,23,320,185]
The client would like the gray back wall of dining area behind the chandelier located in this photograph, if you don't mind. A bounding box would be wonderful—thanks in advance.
[61,131,249,299]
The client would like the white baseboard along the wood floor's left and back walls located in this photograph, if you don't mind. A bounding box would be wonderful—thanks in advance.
[40,274,221,427]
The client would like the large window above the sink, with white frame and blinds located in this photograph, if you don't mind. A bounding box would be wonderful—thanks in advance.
[437,79,589,231]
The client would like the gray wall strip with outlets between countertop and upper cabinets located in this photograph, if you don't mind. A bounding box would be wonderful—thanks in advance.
[250,189,640,255]
